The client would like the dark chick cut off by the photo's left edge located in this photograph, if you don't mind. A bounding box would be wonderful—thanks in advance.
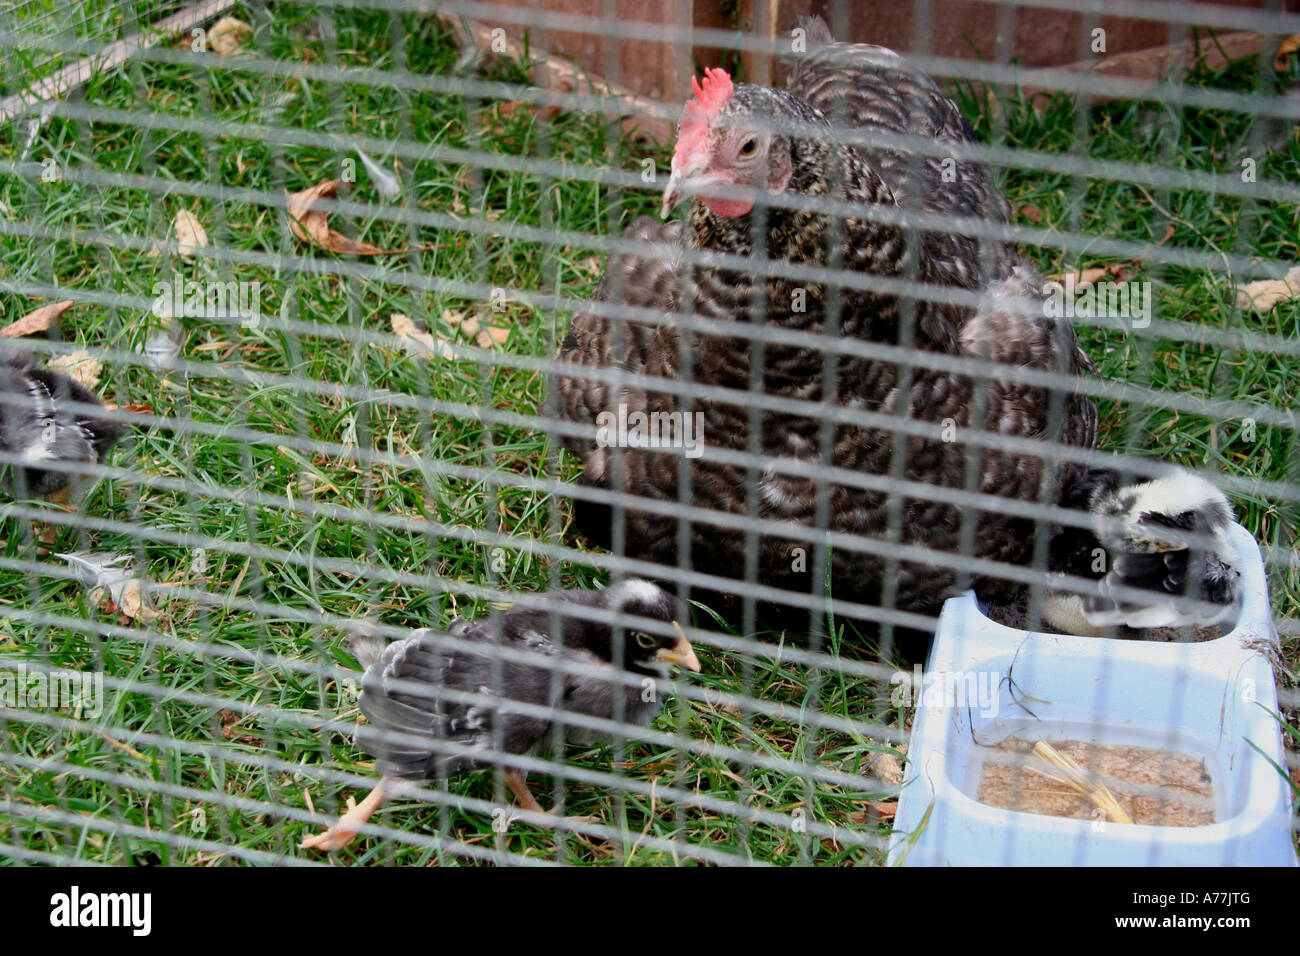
[0,354,121,498]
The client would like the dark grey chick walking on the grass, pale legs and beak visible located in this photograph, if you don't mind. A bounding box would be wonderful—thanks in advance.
[300,580,699,851]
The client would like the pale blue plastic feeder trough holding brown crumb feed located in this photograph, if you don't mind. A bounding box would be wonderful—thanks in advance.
[889,525,1296,866]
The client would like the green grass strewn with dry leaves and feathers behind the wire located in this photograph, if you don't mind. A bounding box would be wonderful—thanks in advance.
[0,5,1300,865]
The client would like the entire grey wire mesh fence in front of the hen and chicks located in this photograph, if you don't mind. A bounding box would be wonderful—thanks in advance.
[0,0,1300,865]
